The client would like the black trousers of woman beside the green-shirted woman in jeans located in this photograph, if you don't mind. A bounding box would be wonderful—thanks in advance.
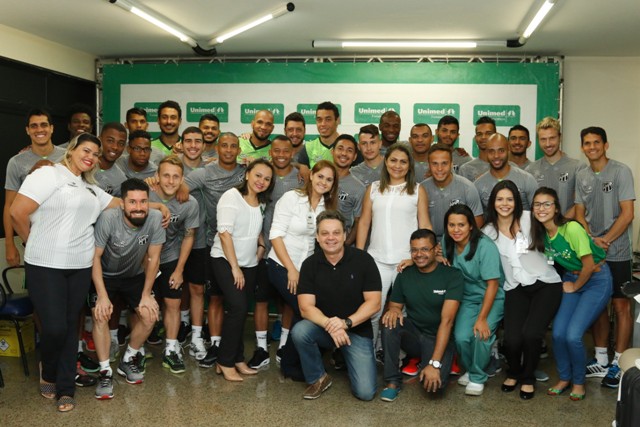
[504,281,562,385]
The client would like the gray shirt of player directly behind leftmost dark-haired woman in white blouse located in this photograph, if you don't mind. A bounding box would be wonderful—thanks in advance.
[184,163,245,246]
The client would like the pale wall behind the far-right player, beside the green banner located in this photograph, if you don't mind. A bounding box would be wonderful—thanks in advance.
[562,57,640,248]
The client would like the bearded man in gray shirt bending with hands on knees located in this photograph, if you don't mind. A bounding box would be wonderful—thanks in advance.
[89,178,165,399]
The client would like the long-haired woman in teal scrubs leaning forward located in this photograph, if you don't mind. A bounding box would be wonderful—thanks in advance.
[442,204,504,396]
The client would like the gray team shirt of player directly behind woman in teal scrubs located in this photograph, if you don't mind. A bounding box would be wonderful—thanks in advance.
[420,174,483,241]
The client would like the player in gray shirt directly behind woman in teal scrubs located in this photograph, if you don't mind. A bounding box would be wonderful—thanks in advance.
[421,143,484,242]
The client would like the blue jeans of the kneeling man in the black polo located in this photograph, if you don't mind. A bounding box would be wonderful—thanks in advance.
[291,319,376,400]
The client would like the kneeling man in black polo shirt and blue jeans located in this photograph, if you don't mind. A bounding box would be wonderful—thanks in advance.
[291,211,382,400]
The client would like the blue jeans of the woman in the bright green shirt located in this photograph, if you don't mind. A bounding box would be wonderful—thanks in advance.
[553,264,612,384]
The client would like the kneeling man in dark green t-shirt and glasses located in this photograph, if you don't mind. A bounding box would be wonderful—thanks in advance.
[380,229,464,402]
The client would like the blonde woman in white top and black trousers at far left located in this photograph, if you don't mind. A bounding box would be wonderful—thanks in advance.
[11,133,120,412]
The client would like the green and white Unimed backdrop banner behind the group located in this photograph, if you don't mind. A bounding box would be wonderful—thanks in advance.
[103,63,559,158]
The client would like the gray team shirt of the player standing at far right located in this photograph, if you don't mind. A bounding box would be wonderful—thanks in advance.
[576,159,636,261]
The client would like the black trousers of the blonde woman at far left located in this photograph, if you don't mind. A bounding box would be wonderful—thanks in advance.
[25,263,91,397]
